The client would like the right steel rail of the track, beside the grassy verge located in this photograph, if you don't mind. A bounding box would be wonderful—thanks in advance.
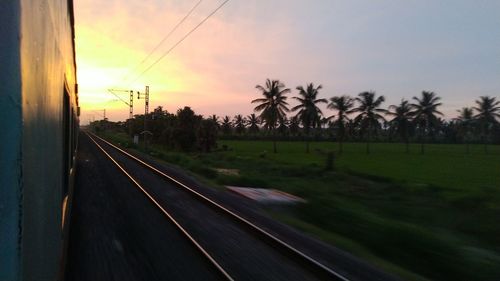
[88,134,350,281]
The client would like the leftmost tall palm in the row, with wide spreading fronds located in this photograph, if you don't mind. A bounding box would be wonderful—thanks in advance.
[252,79,290,153]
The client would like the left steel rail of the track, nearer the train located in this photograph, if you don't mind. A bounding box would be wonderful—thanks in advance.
[85,132,234,281]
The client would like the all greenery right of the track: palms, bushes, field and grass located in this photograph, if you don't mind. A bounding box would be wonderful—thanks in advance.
[90,79,500,281]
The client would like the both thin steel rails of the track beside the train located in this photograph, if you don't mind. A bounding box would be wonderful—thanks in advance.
[87,133,349,281]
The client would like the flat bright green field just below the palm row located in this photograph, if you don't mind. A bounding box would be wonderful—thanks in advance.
[219,141,500,190]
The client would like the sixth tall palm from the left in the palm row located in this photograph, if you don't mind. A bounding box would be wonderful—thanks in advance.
[411,91,443,154]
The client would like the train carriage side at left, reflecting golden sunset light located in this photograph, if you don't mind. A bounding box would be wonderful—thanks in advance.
[0,0,80,280]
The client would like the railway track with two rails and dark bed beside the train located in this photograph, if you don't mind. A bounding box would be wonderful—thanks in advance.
[87,133,349,281]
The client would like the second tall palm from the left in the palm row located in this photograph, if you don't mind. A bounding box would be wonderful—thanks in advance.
[292,83,327,153]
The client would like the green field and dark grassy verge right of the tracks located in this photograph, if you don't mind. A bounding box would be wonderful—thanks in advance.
[95,131,500,280]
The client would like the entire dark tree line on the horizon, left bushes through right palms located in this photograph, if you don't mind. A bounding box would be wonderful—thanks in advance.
[92,79,500,153]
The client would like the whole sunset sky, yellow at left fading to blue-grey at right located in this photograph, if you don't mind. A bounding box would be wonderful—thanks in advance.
[75,0,500,124]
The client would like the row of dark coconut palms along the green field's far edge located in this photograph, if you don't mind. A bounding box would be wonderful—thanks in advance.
[221,79,500,153]
